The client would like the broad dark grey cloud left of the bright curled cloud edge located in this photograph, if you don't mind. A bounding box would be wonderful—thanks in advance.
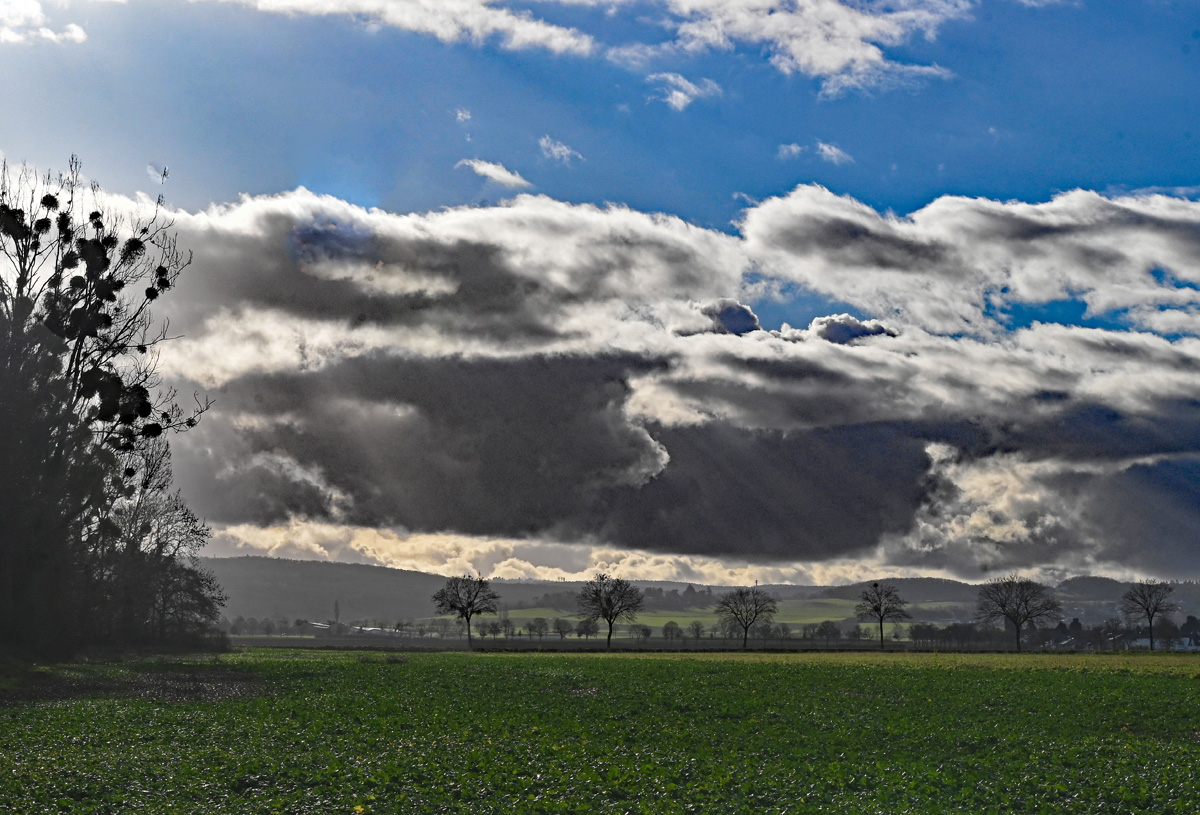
[174,355,665,535]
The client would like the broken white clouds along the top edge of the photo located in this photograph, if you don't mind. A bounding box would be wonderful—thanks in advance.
[16,0,974,94]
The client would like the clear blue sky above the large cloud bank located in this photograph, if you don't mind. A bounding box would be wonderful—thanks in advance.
[9,0,1200,228]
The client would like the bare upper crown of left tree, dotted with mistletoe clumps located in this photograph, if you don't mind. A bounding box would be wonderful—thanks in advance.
[0,158,209,439]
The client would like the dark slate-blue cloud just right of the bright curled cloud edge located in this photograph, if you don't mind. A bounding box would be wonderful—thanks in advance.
[601,424,930,561]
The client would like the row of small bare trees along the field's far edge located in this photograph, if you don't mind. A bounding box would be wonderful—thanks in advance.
[226,574,1200,651]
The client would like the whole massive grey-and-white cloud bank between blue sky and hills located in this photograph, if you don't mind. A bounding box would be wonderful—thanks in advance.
[140,186,1200,577]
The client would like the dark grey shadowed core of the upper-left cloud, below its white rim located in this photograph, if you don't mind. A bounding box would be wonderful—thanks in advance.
[174,214,560,341]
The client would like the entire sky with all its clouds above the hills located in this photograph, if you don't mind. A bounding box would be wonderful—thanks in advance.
[0,0,1200,583]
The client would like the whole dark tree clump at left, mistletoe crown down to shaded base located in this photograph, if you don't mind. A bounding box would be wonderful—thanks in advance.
[0,158,222,654]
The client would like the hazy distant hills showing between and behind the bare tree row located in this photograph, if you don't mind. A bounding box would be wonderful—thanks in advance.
[200,556,1200,622]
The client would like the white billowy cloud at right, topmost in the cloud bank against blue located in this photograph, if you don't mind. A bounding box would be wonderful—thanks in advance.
[742,186,1200,334]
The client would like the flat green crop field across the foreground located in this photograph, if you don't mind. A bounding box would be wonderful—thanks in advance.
[0,651,1200,815]
